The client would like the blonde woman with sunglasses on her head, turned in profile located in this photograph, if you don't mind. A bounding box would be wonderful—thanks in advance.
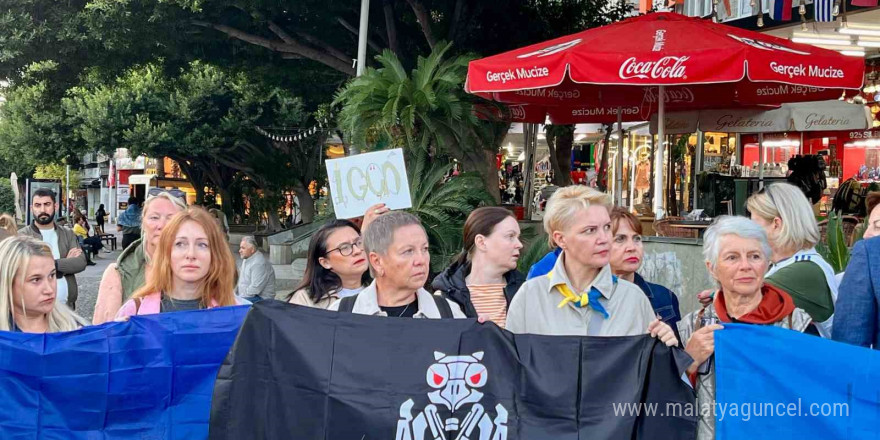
[746,183,838,338]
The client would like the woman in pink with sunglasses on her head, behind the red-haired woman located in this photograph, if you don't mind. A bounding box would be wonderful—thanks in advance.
[92,188,186,325]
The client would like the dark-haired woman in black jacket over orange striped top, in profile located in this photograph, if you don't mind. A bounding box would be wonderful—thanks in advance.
[432,206,525,328]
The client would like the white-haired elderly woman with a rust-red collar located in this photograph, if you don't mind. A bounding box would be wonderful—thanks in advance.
[679,216,810,440]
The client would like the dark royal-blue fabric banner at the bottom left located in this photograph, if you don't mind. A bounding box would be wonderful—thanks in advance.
[0,306,248,440]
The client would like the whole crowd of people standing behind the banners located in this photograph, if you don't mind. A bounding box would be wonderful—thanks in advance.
[0,183,880,439]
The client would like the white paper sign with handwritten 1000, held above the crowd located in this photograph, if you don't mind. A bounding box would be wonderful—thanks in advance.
[327,148,412,218]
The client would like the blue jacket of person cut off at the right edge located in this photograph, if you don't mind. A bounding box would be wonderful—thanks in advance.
[832,237,880,349]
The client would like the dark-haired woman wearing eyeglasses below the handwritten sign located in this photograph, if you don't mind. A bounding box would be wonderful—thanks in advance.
[290,220,369,309]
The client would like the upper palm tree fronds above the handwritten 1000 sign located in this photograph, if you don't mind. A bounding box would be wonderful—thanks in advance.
[334,43,509,201]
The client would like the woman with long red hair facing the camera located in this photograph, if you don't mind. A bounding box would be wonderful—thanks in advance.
[116,207,247,319]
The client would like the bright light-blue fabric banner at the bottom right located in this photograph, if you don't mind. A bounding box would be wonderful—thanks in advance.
[720,324,880,440]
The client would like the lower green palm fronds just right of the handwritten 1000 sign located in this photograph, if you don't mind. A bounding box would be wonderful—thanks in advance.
[407,153,493,273]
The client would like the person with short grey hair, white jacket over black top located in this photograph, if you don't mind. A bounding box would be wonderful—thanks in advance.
[330,211,465,319]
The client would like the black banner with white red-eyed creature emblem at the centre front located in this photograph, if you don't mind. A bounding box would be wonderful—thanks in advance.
[210,301,696,440]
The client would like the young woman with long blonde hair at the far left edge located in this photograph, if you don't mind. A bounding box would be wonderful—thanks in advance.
[0,235,86,333]
